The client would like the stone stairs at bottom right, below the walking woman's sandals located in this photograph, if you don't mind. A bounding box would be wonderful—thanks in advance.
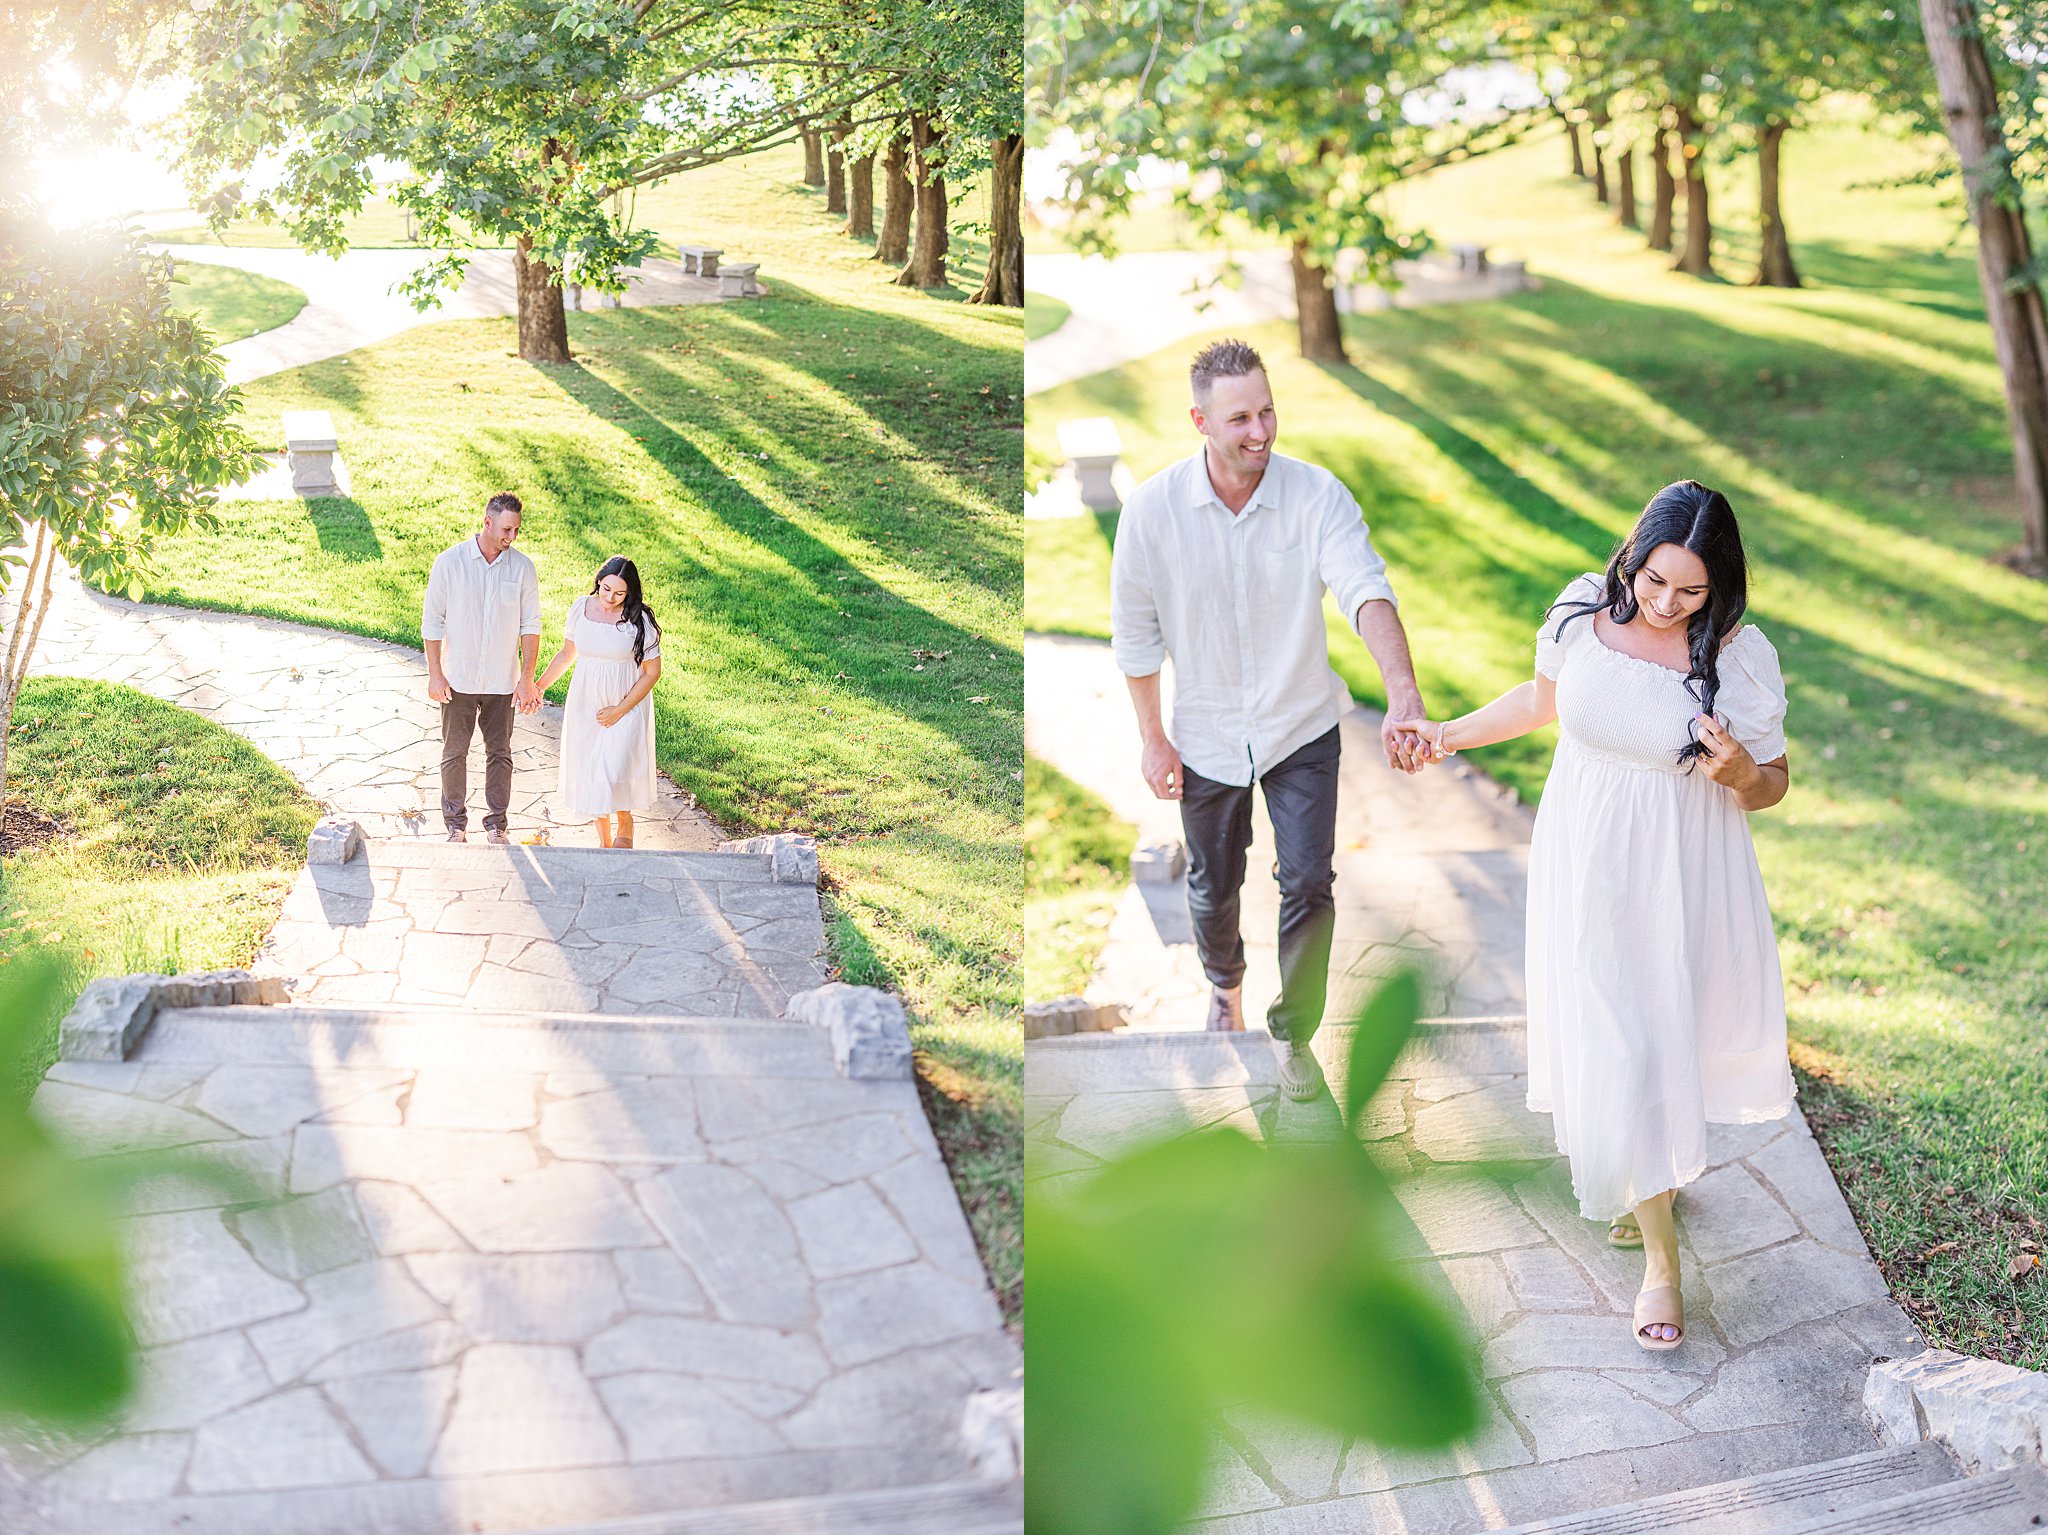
[1507,1443,2048,1535]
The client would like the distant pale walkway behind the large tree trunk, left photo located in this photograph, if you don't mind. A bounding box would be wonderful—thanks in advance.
[158,246,737,383]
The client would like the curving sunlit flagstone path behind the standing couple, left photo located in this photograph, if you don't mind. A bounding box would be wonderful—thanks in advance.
[35,575,723,849]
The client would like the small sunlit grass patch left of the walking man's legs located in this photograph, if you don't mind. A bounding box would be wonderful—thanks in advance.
[1024,757,1137,1001]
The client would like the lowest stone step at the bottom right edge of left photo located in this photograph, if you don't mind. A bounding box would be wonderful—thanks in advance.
[503,1482,1024,1535]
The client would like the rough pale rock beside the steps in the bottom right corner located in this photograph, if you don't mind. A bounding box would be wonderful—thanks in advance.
[1864,1349,2048,1474]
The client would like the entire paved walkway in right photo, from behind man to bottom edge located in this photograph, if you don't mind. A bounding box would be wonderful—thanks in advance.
[1024,637,1921,1535]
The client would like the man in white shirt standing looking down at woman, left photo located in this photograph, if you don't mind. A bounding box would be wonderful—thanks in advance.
[420,493,541,841]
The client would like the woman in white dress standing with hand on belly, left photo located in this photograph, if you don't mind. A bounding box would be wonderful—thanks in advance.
[541,555,662,847]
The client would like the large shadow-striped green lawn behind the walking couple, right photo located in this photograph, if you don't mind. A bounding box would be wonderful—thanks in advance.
[1026,105,2048,1367]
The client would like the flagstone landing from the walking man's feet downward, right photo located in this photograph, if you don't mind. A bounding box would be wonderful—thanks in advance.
[1024,1021,1923,1535]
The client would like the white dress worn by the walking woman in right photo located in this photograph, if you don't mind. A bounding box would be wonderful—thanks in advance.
[1528,575,1792,1220]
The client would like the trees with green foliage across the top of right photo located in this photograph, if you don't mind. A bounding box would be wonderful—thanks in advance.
[1026,0,2048,571]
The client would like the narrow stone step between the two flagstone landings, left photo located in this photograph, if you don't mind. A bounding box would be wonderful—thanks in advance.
[88,1005,838,1085]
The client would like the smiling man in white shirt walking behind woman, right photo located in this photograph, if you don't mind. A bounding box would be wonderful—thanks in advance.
[1110,342,1421,1097]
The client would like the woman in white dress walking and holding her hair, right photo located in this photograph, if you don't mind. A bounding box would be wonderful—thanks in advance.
[1403,479,1792,1349]
